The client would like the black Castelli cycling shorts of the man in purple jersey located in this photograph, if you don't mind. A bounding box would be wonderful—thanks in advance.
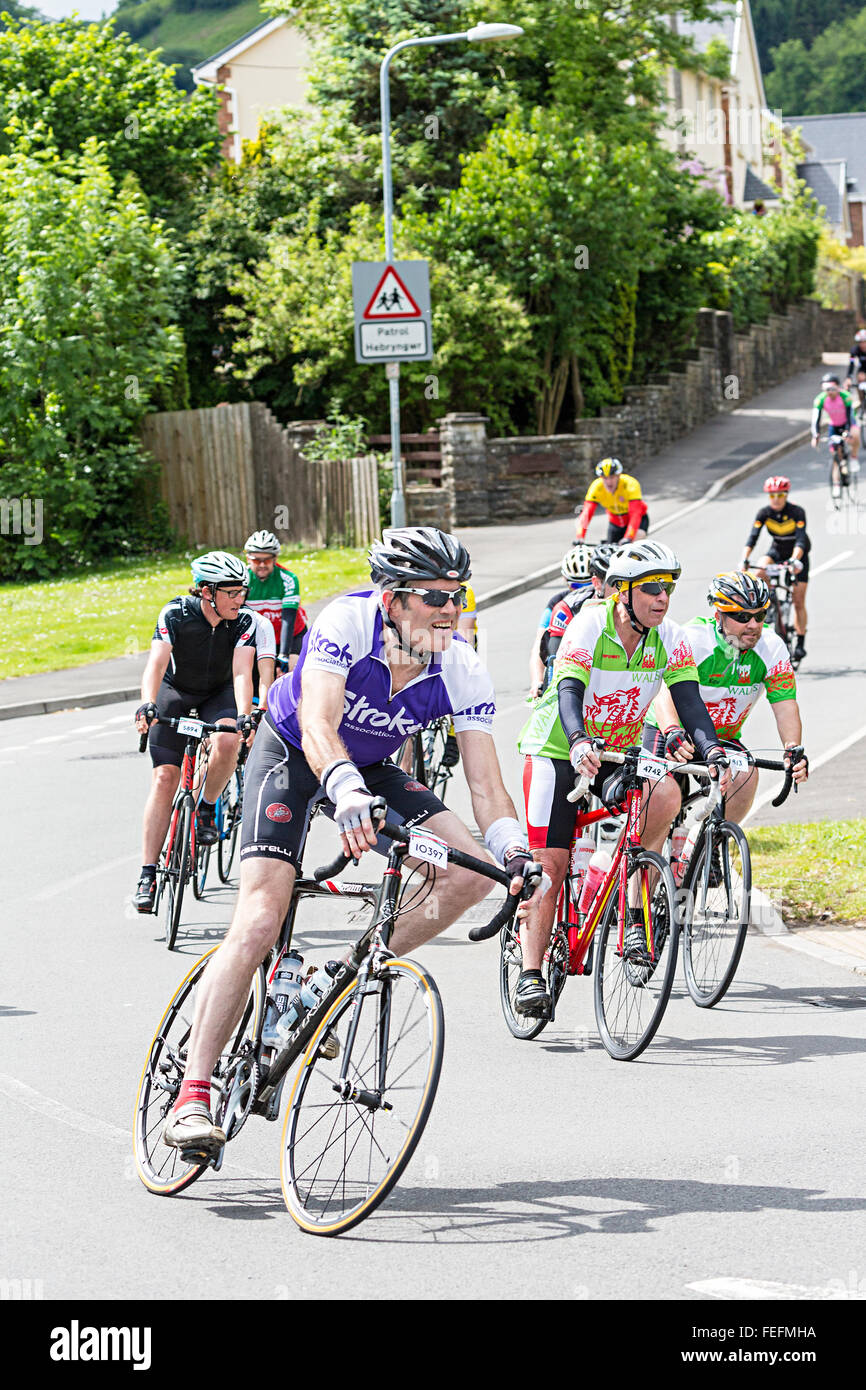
[240,714,446,873]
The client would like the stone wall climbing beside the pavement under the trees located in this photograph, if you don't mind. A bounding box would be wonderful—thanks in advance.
[406,300,856,530]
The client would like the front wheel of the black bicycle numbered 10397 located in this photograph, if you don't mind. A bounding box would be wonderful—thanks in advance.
[281,960,445,1236]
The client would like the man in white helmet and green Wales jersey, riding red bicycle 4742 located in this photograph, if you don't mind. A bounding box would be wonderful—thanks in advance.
[516,541,730,1015]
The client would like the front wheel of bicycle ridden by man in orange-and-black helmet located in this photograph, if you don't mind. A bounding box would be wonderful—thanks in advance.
[683,820,752,1009]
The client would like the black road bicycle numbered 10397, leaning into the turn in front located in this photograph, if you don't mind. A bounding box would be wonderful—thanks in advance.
[135,798,538,1236]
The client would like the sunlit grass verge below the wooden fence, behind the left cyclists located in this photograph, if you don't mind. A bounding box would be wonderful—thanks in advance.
[0,549,370,680]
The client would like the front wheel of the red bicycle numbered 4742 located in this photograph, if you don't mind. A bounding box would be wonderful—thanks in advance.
[594,849,678,1062]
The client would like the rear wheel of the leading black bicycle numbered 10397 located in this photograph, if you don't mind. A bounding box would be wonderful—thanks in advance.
[133,947,267,1197]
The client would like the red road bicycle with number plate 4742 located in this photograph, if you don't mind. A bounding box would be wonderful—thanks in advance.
[470,739,678,1062]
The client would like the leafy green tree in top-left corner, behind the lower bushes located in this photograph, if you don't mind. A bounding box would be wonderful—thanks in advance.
[0,19,220,224]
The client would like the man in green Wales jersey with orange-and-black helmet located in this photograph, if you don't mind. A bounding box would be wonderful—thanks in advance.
[644,570,809,823]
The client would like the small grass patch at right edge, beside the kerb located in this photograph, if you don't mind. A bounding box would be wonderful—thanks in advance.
[749,820,866,924]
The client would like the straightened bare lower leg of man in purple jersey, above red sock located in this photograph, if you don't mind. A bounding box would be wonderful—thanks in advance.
[180,858,295,1079]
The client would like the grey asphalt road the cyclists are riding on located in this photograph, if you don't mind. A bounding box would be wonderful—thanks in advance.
[0,450,866,1300]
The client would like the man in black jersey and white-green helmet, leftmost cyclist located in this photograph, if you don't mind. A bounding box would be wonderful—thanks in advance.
[133,550,256,912]
